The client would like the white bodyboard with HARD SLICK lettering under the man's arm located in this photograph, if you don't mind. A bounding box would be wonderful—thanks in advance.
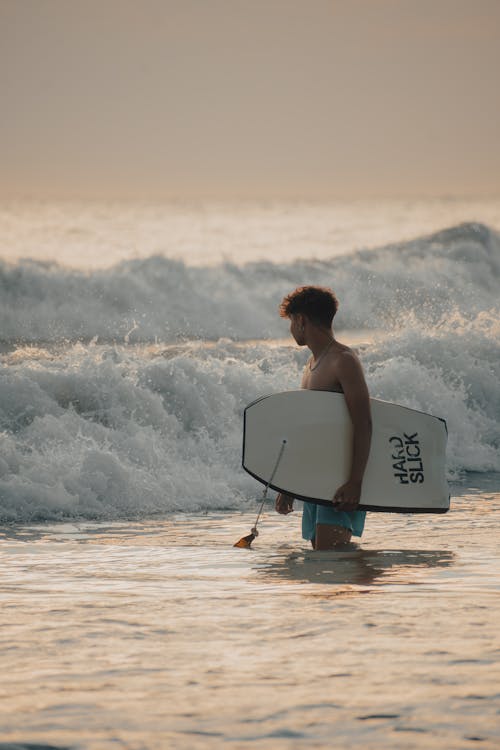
[243,390,450,513]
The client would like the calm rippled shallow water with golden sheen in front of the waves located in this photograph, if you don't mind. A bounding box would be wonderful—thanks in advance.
[0,482,500,750]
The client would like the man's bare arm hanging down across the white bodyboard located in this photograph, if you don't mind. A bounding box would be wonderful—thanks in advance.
[333,352,372,511]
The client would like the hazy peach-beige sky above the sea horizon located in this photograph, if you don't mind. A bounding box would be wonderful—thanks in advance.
[0,0,500,198]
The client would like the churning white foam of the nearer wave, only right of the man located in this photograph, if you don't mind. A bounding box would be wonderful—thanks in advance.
[365,311,500,478]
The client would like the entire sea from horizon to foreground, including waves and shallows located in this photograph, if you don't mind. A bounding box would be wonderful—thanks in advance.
[0,198,500,750]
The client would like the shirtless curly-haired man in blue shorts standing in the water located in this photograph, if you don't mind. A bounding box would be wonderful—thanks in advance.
[276,286,372,550]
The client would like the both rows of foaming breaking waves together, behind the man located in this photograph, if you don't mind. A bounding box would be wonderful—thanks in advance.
[0,220,500,523]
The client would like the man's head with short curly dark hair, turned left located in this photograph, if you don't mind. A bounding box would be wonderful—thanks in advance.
[280,286,339,346]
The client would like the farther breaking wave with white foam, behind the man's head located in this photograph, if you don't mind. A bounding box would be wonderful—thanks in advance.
[0,224,500,344]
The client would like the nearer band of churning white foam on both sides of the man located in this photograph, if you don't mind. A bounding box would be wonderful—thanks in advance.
[0,313,500,522]
